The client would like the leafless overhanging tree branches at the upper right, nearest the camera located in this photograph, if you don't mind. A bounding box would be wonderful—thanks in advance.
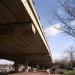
[55,0,75,38]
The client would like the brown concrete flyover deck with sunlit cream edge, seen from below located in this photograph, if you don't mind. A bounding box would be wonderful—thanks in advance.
[0,0,52,72]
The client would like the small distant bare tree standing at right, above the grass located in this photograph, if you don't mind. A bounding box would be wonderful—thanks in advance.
[65,47,75,66]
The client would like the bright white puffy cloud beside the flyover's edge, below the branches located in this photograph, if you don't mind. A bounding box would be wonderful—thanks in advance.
[45,23,61,36]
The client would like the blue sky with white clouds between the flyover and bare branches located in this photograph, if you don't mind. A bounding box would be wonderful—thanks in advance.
[34,0,75,61]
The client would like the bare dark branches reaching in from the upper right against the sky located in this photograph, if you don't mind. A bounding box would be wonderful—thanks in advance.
[49,0,75,38]
